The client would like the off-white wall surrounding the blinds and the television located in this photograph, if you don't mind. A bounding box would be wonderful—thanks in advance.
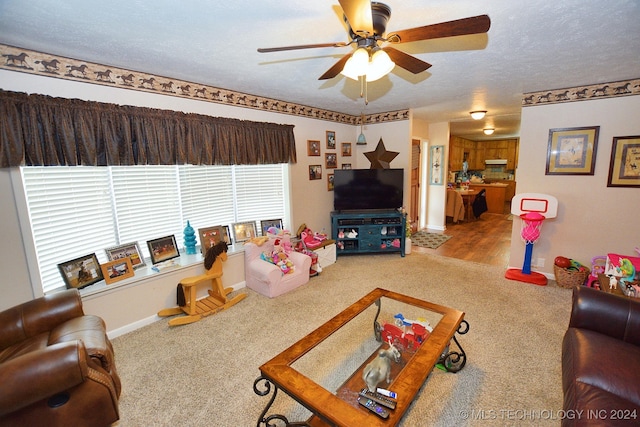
[0,70,410,333]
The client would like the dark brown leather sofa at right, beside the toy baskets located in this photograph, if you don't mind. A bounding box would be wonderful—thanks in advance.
[562,286,640,426]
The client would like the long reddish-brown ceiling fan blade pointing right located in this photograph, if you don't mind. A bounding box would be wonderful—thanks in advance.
[387,15,491,43]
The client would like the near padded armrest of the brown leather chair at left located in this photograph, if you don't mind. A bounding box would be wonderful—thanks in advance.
[0,341,88,417]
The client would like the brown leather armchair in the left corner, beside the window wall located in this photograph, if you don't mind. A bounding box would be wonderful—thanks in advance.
[0,289,121,426]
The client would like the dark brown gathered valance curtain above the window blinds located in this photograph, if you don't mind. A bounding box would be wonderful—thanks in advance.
[0,90,296,167]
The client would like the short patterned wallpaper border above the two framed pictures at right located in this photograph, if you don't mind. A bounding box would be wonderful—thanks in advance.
[522,79,640,107]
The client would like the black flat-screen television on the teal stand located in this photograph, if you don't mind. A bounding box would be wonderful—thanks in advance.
[333,169,404,211]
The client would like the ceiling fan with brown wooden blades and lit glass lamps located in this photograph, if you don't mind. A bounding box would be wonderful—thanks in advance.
[258,0,491,82]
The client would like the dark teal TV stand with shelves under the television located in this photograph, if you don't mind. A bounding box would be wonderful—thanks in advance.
[331,210,405,256]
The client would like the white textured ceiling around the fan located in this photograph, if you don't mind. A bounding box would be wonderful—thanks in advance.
[0,0,640,140]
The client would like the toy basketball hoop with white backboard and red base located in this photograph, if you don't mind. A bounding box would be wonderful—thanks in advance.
[505,193,558,285]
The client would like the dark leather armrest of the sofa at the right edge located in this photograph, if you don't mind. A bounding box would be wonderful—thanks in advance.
[569,286,640,345]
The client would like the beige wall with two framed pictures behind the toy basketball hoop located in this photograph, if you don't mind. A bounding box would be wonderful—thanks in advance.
[509,96,640,277]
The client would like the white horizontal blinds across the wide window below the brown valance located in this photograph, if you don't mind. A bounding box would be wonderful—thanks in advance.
[21,164,288,293]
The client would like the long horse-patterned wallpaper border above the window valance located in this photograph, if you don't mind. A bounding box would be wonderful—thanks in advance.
[0,43,409,125]
